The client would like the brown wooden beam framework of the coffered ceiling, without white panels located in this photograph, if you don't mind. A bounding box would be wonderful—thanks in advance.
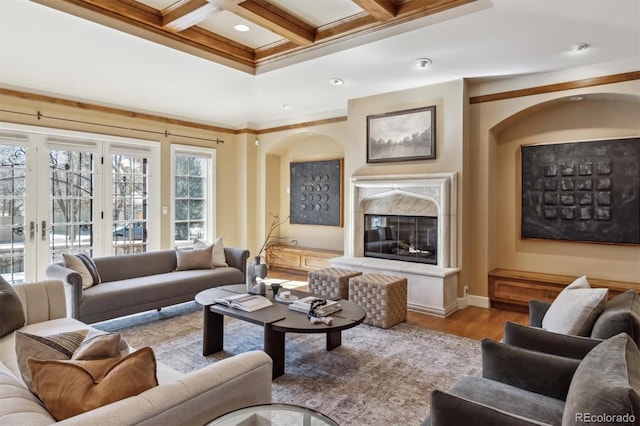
[35,0,477,73]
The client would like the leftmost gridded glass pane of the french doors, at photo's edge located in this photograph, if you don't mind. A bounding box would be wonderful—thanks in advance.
[0,142,27,283]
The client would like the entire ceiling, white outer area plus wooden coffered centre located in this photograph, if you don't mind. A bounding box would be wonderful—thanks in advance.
[0,0,640,130]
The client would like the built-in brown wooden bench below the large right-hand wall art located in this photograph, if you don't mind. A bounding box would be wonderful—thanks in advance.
[489,269,640,312]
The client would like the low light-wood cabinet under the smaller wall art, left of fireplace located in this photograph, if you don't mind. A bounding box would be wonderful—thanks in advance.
[266,245,342,273]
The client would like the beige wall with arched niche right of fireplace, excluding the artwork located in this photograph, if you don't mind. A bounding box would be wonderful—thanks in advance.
[465,80,640,295]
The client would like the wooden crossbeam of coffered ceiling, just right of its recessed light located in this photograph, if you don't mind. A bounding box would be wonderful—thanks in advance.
[209,0,315,46]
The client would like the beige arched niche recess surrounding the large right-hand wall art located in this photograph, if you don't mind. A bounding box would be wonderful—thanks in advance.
[487,93,640,282]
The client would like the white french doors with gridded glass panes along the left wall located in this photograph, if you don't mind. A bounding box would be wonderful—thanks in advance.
[0,126,159,282]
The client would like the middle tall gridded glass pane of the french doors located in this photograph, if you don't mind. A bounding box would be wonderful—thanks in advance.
[47,150,95,263]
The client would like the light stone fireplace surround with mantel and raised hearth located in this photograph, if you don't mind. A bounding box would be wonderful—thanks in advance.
[331,173,459,317]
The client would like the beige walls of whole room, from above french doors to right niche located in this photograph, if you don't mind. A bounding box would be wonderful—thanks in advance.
[0,69,640,297]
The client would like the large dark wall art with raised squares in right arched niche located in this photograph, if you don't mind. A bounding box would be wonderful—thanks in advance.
[521,138,640,244]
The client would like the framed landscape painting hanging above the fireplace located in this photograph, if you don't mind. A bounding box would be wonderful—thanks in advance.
[367,106,436,163]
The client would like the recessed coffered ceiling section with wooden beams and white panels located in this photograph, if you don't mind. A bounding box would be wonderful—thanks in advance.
[35,0,476,73]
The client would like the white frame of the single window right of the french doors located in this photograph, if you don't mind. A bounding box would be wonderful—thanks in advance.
[170,143,217,246]
